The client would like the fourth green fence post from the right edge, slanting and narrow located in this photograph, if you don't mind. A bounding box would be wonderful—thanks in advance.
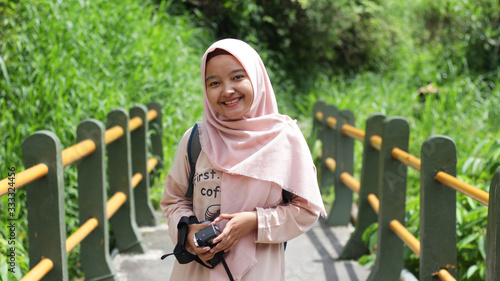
[340,114,385,259]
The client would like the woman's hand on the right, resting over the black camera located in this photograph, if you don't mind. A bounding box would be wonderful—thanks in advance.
[211,211,257,253]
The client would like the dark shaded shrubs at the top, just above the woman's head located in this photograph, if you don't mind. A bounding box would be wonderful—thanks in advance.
[168,0,406,91]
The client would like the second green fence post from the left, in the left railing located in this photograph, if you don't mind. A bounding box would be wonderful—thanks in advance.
[77,119,117,280]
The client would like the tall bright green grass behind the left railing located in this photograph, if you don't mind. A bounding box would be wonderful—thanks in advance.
[0,0,211,280]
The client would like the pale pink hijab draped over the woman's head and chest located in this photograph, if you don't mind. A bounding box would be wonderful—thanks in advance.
[199,39,326,280]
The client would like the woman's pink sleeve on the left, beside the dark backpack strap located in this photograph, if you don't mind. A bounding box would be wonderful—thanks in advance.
[160,130,194,244]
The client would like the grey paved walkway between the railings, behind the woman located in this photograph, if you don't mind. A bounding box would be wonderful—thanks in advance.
[113,211,370,281]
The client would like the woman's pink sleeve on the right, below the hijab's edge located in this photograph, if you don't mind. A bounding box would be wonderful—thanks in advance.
[255,196,320,243]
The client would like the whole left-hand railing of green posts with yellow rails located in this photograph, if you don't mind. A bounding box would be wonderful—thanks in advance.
[0,102,163,281]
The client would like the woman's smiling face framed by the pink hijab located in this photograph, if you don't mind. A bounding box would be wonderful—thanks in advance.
[205,55,253,120]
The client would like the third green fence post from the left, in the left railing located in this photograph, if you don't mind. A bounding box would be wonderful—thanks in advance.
[107,108,146,253]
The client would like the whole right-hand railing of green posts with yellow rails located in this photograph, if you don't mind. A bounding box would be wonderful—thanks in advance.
[313,102,500,281]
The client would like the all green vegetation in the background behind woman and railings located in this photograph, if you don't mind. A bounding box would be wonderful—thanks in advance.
[0,0,500,280]
